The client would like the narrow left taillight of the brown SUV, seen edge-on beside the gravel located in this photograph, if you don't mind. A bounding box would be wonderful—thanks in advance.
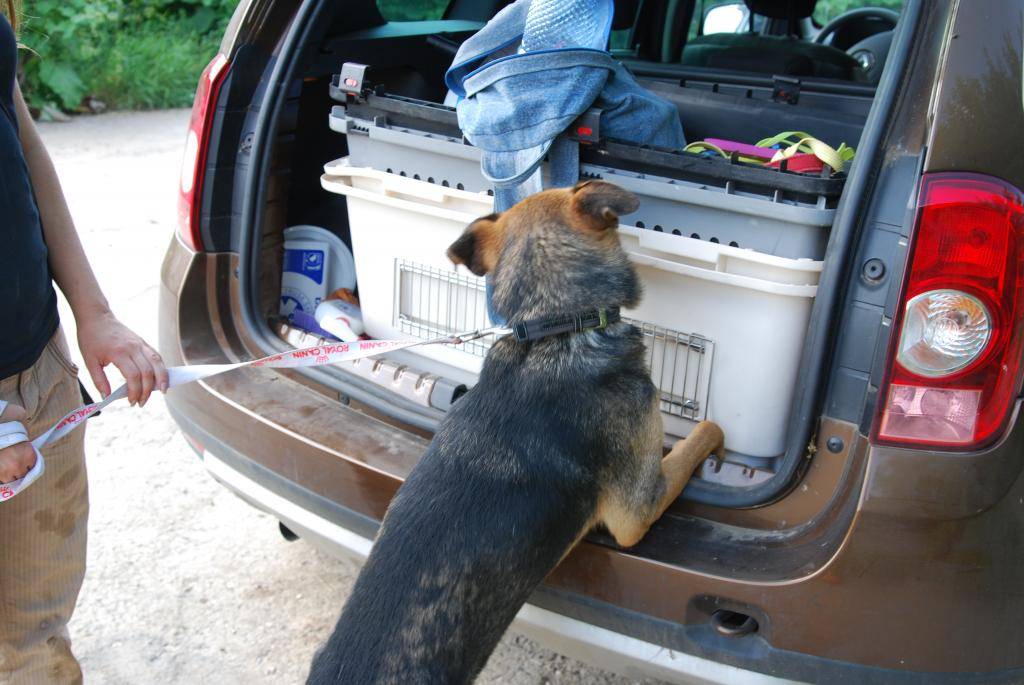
[178,54,227,251]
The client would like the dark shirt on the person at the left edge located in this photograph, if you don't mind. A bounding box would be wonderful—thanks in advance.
[0,13,57,379]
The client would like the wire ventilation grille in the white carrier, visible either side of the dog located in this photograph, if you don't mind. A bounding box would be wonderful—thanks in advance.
[393,259,715,421]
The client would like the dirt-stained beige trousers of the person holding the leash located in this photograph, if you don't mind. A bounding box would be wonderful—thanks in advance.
[0,331,89,685]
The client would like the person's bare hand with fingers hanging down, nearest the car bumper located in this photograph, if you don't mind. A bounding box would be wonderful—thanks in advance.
[76,313,167,406]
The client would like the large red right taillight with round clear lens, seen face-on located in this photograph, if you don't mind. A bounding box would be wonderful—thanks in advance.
[872,173,1024,449]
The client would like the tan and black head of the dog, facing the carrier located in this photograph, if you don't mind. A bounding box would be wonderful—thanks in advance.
[447,181,640,320]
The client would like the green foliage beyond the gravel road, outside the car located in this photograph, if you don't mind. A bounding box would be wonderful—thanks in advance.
[18,0,238,111]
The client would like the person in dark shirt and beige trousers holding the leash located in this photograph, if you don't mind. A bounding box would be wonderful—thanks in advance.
[0,0,168,684]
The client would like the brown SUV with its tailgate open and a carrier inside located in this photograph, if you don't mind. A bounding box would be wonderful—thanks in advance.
[160,0,1024,683]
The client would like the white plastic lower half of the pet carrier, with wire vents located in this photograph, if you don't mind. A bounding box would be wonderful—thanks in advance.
[321,159,821,457]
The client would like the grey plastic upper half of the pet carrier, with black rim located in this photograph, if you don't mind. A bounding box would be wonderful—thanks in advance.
[330,90,843,259]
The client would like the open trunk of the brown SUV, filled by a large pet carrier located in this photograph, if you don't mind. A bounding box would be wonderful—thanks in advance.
[234,0,921,520]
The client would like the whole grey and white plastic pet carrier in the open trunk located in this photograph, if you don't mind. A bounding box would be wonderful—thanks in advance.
[322,63,844,458]
